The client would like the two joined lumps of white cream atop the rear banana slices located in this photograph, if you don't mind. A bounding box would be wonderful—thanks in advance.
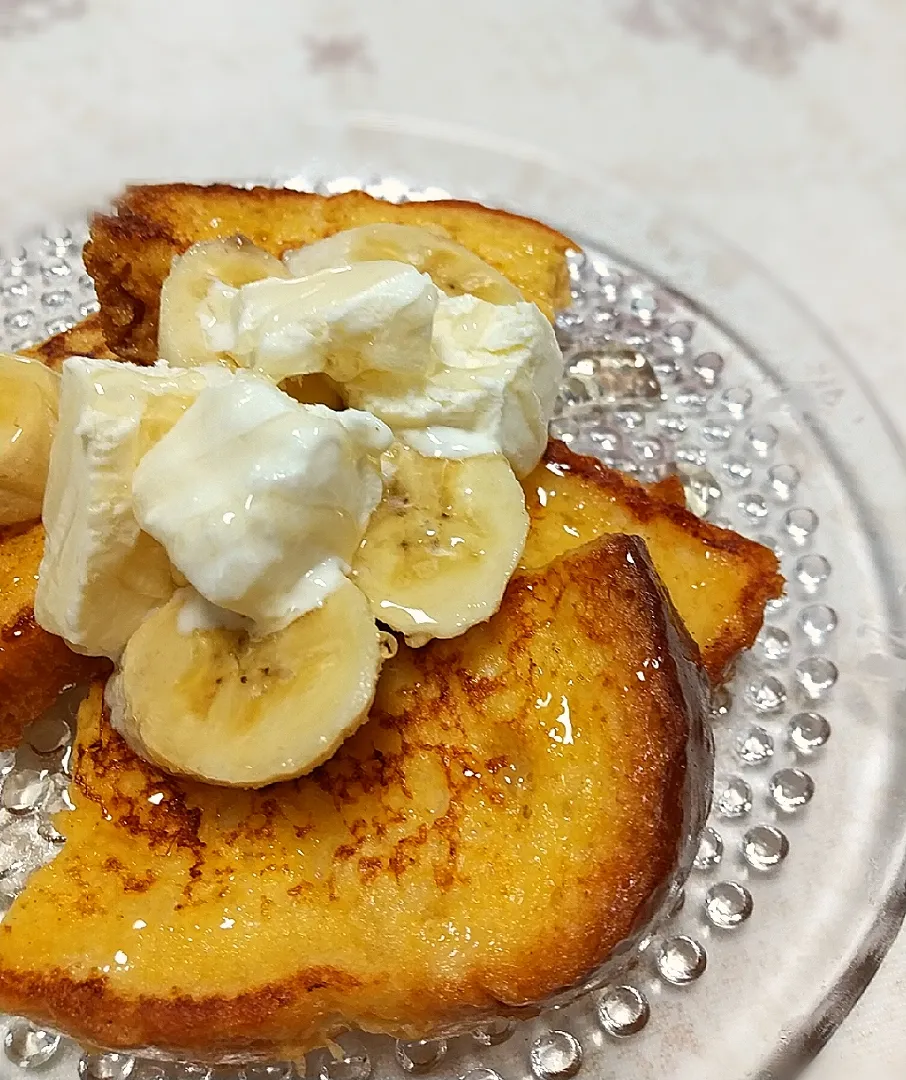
[199,260,563,476]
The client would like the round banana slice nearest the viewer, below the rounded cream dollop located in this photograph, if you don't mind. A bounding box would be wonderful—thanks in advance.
[107,581,381,787]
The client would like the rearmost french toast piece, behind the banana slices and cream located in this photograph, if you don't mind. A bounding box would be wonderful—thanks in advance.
[84,184,577,364]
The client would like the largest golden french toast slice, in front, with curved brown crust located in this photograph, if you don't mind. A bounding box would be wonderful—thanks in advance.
[0,537,709,1061]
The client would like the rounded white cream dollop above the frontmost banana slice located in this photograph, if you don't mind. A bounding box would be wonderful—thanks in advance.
[132,373,392,634]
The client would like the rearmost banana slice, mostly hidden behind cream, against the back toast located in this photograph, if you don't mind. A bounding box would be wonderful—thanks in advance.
[283,222,525,303]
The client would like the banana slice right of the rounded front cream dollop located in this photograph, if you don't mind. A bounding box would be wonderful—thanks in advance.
[353,443,528,646]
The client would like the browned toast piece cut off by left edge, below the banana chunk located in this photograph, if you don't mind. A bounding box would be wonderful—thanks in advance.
[0,522,110,750]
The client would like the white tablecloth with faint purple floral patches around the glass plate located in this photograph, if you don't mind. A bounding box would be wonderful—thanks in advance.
[0,0,906,1080]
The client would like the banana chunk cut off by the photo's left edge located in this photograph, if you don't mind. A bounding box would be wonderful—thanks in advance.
[0,353,59,526]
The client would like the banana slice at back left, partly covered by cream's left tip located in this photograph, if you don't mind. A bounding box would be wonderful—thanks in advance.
[158,237,289,367]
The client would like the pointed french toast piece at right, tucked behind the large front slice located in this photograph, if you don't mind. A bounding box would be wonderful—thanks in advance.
[523,442,783,683]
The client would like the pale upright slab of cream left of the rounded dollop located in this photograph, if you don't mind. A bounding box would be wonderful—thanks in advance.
[35,356,231,659]
